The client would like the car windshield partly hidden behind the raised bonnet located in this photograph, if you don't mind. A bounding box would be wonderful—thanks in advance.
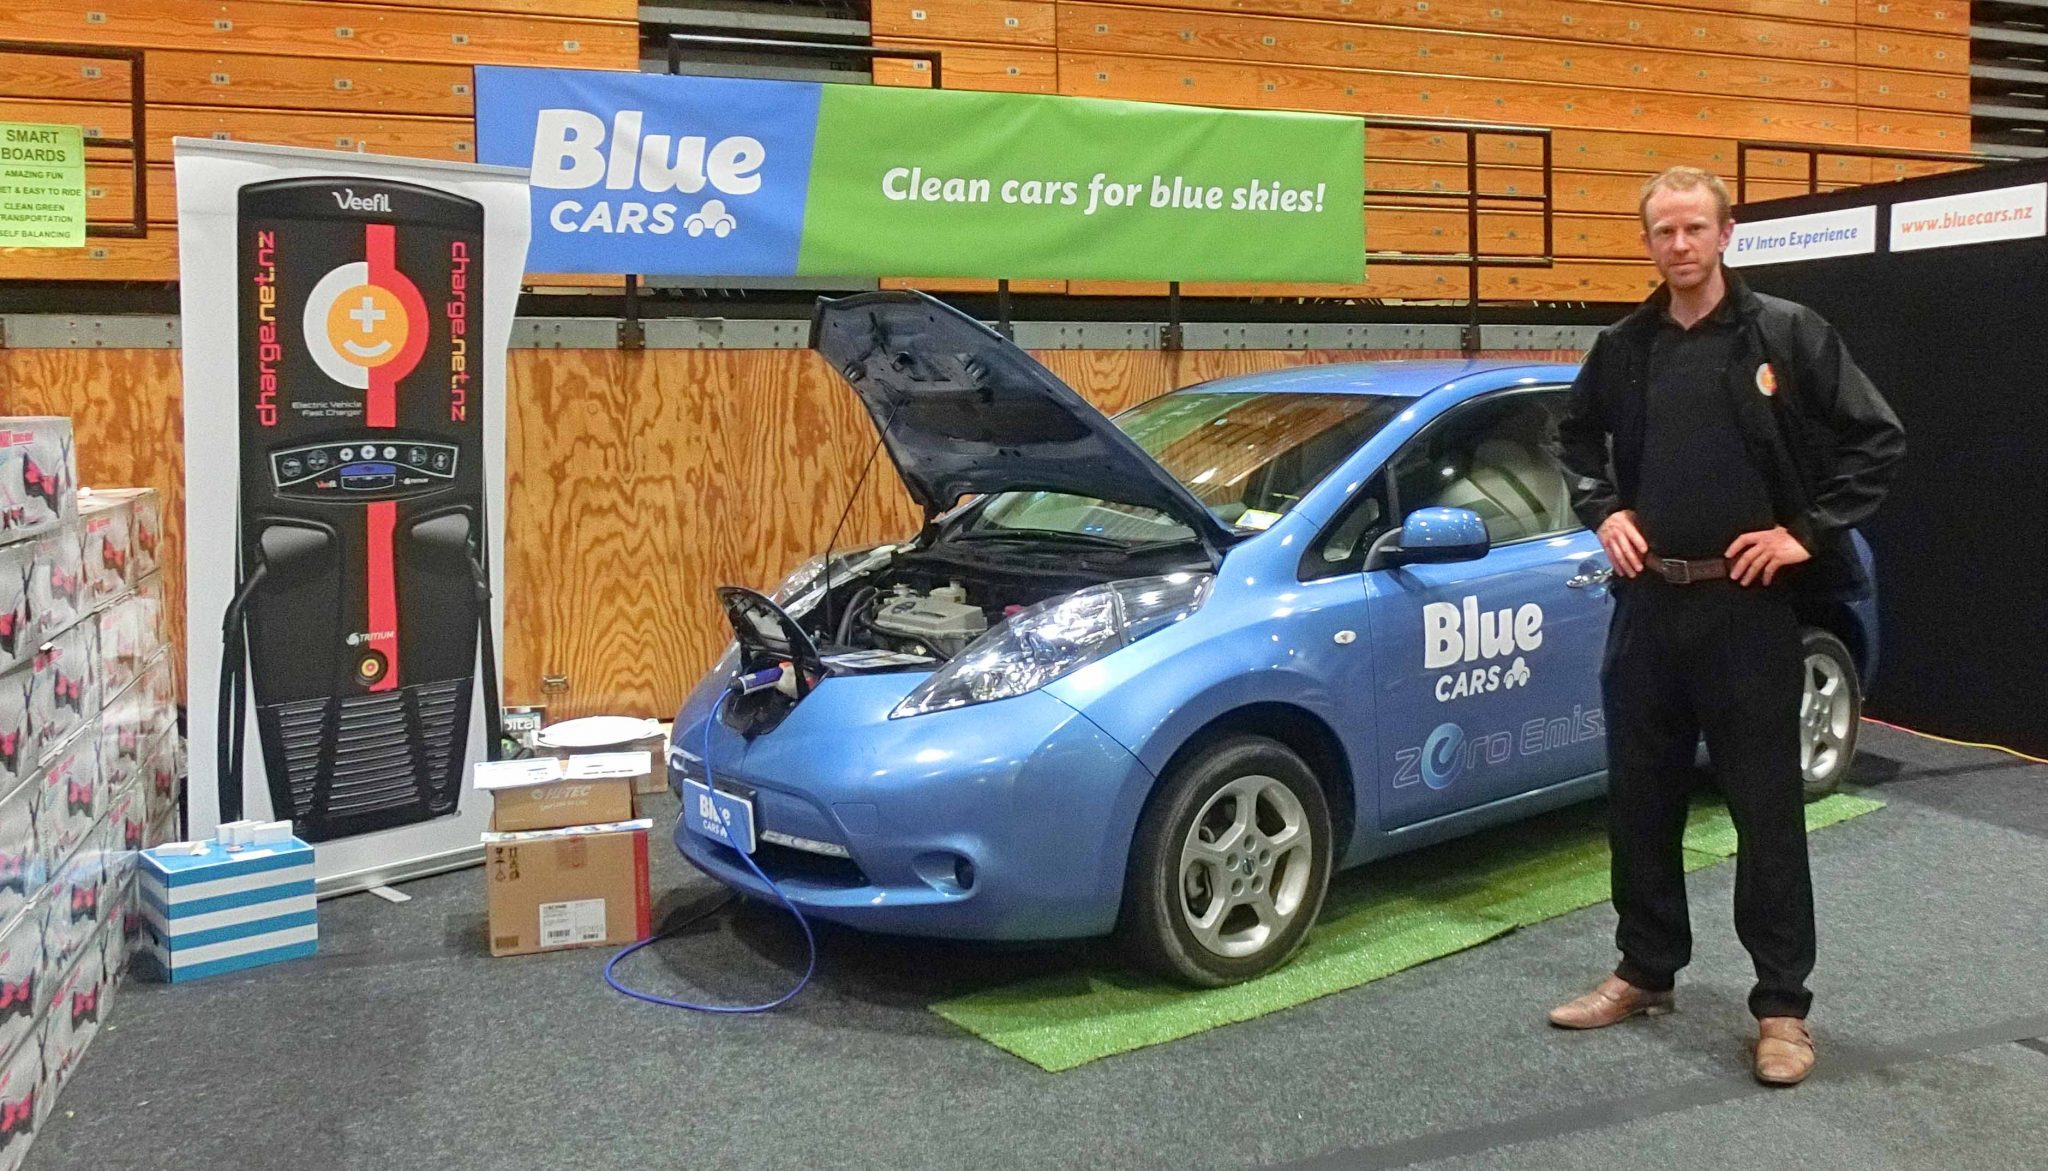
[967,387,1413,545]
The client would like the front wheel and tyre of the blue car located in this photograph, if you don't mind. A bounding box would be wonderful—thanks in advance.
[1116,735,1333,989]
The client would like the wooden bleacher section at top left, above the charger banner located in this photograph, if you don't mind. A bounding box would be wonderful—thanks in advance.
[0,0,639,280]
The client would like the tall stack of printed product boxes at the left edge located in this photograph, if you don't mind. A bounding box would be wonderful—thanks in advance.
[0,446,180,1171]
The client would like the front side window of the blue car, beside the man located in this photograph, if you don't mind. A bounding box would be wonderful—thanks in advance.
[1389,391,1579,545]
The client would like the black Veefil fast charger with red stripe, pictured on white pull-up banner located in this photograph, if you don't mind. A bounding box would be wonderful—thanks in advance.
[221,178,496,841]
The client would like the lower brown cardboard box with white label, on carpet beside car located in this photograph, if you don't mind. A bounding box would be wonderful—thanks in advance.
[483,819,653,956]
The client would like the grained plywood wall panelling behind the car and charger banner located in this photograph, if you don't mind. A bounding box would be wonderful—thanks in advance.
[0,339,1577,717]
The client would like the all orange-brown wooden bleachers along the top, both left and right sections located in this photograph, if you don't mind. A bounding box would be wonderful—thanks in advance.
[0,0,1970,301]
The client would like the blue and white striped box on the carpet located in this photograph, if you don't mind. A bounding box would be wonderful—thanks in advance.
[137,837,319,983]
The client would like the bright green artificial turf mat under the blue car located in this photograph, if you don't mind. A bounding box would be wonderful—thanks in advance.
[932,794,1882,1073]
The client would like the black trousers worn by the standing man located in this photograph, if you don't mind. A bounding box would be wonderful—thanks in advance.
[1599,573,1815,1017]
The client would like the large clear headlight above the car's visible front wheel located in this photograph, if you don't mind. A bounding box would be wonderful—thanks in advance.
[889,573,1214,719]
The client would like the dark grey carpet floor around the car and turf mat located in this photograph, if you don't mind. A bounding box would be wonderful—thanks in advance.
[27,729,2048,1171]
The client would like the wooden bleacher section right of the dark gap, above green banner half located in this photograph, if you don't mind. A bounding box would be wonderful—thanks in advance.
[872,0,1970,301]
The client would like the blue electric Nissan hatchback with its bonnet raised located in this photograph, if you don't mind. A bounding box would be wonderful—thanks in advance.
[670,293,1876,985]
